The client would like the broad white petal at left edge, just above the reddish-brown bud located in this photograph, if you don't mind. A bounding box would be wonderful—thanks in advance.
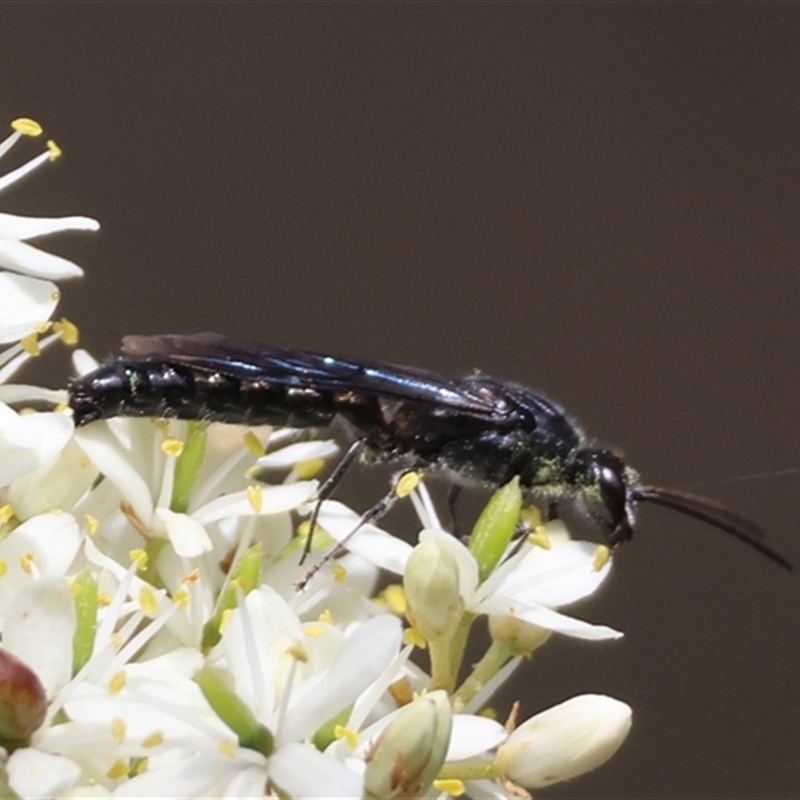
[3,578,75,697]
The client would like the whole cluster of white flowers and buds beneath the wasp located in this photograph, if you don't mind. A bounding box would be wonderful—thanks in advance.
[0,120,631,800]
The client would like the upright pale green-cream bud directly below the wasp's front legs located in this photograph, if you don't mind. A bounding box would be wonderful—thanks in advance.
[403,539,464,641]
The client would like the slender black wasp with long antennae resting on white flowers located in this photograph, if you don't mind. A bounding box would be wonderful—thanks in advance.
[69,333,792,569]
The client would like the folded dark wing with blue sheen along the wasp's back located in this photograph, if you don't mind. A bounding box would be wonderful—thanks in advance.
[122,333,504,422]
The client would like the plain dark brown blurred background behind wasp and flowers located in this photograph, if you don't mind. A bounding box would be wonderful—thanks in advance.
[0,3,800,797]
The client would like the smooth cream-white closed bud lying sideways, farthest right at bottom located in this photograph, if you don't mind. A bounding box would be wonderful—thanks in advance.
[495,694,632,789]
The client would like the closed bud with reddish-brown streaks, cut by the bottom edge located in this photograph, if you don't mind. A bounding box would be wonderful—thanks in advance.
[364,691,452,800]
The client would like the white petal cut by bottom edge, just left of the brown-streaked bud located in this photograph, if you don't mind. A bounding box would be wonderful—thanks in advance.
[269,743,364,800]
